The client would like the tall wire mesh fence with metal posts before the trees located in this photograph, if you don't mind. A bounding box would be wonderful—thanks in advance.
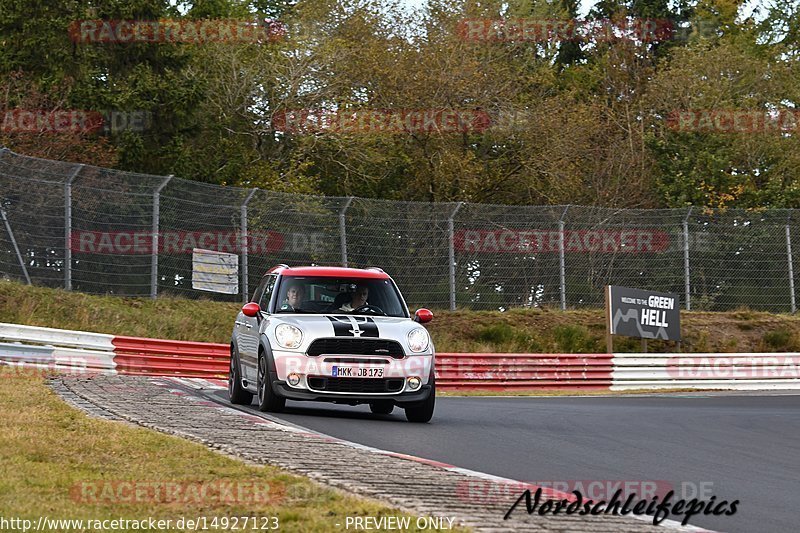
[0,145,800,312]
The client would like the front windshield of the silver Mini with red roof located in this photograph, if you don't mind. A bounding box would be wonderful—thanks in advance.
[275,276,408,317]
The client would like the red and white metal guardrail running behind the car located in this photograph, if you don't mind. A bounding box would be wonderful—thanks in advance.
[0,323,800,391]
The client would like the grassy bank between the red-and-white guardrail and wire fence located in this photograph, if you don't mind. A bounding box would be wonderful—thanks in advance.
[0,281,800,353]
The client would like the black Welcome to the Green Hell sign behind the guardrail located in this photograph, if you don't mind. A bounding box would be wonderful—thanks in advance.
[606,285,681,341]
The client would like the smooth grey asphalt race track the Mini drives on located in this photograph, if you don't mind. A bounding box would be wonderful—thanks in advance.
[209,391,800,532]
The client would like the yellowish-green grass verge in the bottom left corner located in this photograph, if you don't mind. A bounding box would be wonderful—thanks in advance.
[0,368,466,532]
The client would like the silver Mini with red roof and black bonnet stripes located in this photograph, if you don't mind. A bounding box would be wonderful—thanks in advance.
[228,265,436,422]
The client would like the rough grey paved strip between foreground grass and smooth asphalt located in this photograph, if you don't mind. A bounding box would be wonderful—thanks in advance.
[51,375,676,533]
